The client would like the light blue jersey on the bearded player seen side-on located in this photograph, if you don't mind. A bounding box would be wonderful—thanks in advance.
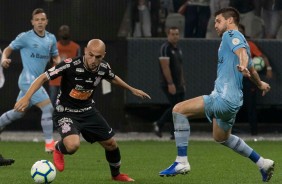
[214,30,251,106]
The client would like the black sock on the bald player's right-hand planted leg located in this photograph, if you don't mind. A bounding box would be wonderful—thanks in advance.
[105,148,121,177]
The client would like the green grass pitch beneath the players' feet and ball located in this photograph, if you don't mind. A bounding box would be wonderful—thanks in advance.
[0,141,282,184]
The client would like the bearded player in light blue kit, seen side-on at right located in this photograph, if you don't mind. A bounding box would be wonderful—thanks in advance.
[159,8,274,182]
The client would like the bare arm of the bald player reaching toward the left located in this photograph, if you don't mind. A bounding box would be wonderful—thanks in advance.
[14,73,48,112]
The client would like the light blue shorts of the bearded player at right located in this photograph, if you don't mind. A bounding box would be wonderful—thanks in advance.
[203,93,241,131]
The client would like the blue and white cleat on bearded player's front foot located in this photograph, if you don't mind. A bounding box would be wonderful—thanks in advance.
[159,162,191,177]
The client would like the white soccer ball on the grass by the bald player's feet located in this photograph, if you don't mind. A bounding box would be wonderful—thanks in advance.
[30,160,56,184]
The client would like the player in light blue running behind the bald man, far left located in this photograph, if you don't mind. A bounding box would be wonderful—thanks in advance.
[0,8,60,152]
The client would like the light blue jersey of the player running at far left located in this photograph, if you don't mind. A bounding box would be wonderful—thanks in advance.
[9,30,59,85]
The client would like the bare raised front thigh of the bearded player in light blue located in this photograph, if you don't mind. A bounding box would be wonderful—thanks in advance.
[173,96,205,118]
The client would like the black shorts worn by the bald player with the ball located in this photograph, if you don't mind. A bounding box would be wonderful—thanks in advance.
[53,108,115,143]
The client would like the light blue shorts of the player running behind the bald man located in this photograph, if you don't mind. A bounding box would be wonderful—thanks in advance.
[17,84,49,106]
